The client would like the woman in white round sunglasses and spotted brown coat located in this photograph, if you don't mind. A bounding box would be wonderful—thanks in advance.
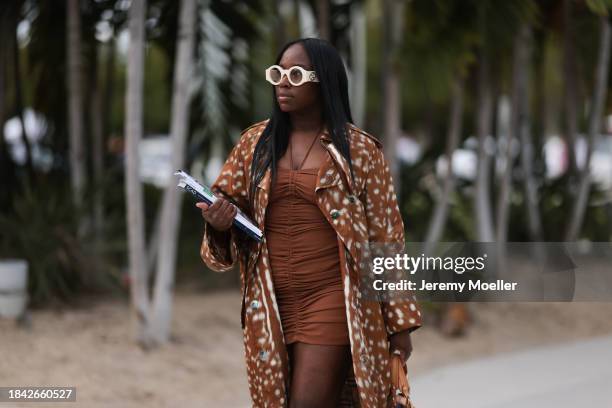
[197,38,421,408]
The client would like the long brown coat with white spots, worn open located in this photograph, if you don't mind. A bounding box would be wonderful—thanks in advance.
[201,121,421,408]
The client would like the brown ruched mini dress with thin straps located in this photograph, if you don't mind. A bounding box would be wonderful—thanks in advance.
[265,136,350,345]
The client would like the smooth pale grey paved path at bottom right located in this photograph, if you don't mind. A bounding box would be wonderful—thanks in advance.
[410,336,612,408]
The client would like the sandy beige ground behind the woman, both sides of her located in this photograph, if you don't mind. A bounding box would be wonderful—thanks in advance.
[0,291,612,407]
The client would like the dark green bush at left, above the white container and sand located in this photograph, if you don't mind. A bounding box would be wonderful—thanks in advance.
[0,182,118,305]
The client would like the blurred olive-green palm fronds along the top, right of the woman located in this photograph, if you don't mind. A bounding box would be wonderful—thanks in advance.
[401,0,537,109]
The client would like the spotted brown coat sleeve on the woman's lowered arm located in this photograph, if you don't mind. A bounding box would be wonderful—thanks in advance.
[363,143,421,336]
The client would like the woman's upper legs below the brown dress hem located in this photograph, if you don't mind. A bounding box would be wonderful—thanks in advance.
[287,342,352,408]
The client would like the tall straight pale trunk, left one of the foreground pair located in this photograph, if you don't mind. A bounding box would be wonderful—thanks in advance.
[125,0,152,347]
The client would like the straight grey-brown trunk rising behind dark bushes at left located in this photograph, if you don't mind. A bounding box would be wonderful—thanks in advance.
[67,0,85,215]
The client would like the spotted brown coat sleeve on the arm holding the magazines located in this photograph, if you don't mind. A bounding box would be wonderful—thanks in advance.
[200,133,248,272]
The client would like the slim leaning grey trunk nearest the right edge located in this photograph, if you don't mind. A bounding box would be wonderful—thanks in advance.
[565,17,610,241]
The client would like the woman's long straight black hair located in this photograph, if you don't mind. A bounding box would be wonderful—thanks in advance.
[249,38,354,209]
